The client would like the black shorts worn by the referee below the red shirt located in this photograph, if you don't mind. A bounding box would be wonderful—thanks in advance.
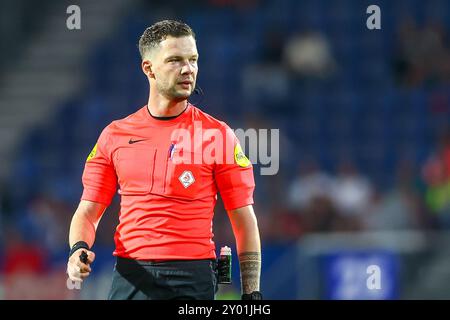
[108,257,218,300]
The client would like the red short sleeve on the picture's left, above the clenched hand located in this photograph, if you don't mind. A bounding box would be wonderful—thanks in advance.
[81,127,117,206]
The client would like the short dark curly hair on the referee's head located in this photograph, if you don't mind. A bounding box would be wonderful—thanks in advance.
[139,20,195,59]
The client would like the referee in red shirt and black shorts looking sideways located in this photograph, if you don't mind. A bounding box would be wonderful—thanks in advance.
[67,20,262,300]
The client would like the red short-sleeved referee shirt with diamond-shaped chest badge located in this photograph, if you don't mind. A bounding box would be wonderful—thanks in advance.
[81,104,255,260]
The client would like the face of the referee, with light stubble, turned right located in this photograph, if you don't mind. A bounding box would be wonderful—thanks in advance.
[150,36,198,101]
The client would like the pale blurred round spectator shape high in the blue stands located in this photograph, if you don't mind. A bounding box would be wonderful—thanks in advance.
[284,32,336,79]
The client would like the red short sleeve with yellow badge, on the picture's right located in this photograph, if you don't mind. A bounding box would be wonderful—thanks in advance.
[214,126,255,211]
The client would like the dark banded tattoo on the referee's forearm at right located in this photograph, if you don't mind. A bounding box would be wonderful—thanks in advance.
[239,252,261,293]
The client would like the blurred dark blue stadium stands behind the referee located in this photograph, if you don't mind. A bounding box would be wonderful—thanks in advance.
[0,0,450,299]
